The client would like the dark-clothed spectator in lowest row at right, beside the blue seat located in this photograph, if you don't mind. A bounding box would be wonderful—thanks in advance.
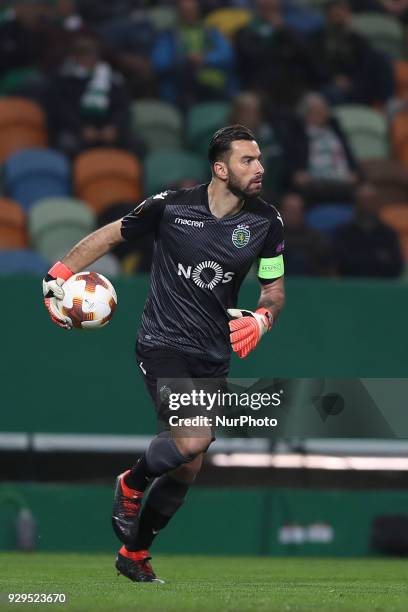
[335,183,403,277]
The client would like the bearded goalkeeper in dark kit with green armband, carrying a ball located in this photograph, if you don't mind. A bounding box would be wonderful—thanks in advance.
[43,125,284,582]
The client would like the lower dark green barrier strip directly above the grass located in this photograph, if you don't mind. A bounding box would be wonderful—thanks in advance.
[0,483,408,557]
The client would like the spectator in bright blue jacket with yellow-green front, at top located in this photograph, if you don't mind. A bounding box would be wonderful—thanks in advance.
[152,0,234,107]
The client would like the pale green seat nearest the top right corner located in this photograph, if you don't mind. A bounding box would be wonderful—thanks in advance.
[353,13,404,60]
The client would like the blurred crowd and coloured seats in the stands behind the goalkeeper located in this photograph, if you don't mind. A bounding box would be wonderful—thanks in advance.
[0,0,408,278]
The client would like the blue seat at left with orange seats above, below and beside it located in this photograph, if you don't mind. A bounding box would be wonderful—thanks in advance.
[4,149,71,209]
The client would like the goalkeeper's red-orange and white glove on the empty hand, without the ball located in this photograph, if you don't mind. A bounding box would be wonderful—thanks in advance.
[227,308,273,359]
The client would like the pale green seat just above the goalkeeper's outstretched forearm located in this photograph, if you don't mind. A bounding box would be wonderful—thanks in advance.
[28,198,95,261]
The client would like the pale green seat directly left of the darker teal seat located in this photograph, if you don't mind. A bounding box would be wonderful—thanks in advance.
[132,100,183,151]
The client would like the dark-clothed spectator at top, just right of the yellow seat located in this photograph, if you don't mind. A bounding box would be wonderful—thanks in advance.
[235,0,315,106]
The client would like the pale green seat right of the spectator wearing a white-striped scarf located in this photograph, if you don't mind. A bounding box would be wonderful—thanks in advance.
[334,104,390,160]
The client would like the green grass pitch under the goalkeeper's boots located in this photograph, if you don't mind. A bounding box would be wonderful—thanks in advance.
[0,553,408,612]
